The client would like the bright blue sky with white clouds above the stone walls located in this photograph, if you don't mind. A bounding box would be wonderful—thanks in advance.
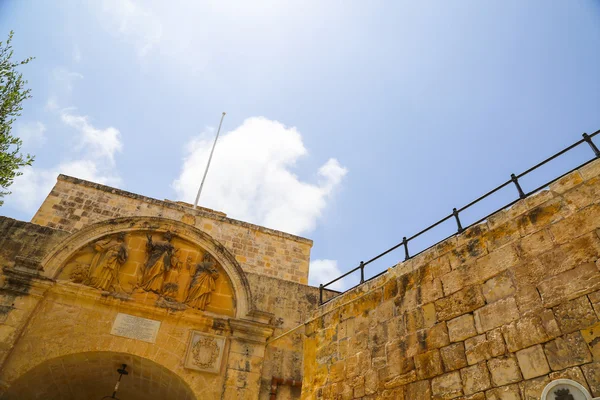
[0,0,600,285]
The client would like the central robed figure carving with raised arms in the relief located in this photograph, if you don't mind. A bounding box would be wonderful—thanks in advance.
[142,232,175,294]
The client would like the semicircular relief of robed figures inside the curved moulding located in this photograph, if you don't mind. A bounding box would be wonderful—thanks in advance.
[59,232,232,310]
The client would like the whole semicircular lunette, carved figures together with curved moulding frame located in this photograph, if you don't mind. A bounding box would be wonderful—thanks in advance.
[42,217,253,317]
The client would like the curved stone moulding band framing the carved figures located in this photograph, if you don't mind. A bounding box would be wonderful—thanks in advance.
[41,217,254,318]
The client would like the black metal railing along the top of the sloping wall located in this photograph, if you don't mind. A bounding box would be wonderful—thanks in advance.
[319,130,600,304]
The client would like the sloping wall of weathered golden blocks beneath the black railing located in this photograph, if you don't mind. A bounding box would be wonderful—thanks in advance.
[302,161,600,400]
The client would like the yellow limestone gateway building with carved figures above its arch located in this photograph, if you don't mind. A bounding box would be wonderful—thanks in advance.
[0,176,318,400]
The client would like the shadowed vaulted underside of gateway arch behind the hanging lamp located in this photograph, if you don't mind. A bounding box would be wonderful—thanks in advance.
[2,351,196,400]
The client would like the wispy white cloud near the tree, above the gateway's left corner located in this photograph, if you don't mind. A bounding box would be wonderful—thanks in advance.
[4,109,122,213]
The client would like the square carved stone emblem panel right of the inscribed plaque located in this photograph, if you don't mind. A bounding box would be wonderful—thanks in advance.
[184,331,225,373]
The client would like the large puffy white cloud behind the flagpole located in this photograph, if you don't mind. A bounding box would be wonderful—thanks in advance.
[173,117,347,234]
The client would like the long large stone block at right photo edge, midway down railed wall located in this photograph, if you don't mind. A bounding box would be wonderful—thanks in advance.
[538,263,600,307]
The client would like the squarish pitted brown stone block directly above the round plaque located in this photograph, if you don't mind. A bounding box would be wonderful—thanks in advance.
[544,332,592,371]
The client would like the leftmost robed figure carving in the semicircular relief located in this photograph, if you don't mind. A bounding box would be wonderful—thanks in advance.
[86,232,128,290]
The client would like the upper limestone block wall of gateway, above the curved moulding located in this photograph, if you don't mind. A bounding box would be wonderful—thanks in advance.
[31,175,312,284]
